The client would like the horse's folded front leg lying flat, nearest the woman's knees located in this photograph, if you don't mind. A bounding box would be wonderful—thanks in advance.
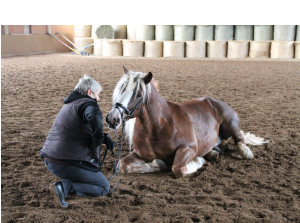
[120,151,167,173]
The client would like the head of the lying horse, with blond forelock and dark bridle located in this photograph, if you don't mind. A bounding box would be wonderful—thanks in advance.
[106,66,152,129]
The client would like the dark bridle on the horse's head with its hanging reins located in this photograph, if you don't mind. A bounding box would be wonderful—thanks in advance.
[102,98,144,194]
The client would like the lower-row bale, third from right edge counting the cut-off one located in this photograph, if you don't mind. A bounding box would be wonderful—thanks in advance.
[249,41,271,58]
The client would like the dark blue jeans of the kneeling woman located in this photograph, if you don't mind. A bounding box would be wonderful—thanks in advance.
[45,161,110,197]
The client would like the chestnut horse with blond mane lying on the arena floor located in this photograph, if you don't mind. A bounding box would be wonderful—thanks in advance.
[106,66,268,178]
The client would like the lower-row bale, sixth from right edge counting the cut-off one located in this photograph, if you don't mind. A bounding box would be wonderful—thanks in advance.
[185,41,206,58]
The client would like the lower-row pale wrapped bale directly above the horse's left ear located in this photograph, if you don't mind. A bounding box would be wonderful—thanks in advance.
[123,40,144,57]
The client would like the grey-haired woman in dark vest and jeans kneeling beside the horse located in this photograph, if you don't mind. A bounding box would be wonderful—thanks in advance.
[40,75,114,207]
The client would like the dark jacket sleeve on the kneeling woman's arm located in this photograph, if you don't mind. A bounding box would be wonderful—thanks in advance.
[82,104,104,161]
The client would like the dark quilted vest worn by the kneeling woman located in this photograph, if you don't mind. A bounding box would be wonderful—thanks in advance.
[40,98,100,167]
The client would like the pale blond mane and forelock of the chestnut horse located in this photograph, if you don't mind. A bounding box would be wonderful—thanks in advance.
[113,70,159,151]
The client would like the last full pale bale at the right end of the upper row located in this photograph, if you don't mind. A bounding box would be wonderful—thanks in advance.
[274,25,296,41]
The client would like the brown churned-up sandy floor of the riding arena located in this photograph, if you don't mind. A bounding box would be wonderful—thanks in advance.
[1,53,300,223]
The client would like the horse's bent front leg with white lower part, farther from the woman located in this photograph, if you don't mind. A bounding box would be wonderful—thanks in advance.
[172,146,205,178]
